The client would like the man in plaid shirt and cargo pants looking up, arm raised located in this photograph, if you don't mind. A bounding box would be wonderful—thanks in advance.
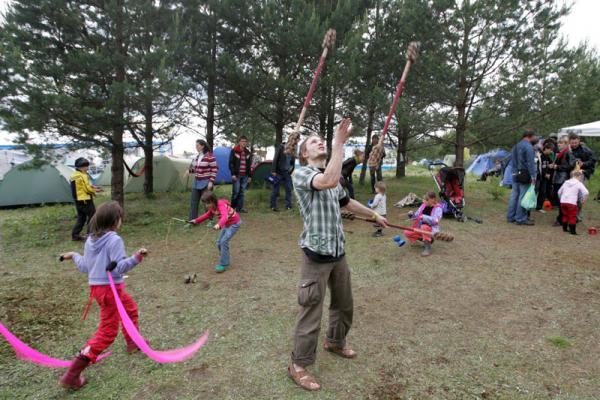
[288,118,387,390]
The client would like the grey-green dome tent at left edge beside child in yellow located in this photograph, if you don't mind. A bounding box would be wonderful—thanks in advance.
[0,162,73,207]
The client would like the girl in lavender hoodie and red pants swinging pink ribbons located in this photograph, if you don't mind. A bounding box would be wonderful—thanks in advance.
[59,201,148,389]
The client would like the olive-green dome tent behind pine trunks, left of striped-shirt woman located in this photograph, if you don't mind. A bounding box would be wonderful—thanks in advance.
[125,156,193,193]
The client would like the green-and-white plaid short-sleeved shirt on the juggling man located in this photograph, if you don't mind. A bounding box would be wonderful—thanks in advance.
[292,166,346,257]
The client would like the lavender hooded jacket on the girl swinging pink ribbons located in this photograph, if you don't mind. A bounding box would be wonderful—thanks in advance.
[73,232,142,285]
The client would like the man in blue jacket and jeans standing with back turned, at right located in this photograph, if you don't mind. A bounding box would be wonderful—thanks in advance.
[506,129,537,225]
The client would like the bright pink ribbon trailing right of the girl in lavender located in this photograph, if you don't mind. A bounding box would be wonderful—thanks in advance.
[107,272,208,364]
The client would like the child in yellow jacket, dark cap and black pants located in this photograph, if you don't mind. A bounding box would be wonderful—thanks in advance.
[69,157,101,241]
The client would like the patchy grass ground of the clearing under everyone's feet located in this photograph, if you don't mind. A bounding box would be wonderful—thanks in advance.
[0,170,600,399]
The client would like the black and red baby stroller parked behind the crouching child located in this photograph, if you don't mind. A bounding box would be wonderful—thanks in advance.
[429,162,467,222]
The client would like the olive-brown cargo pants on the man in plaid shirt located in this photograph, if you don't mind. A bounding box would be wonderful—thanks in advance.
[292,253,353,367]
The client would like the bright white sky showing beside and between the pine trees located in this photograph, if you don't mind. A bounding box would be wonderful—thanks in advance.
[0,0,600,153]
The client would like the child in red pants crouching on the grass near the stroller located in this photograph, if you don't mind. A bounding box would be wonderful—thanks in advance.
[404,192,443,257]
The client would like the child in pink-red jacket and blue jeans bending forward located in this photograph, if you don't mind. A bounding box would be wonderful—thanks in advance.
[189,191,242,273]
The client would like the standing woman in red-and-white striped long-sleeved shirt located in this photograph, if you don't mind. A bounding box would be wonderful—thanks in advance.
[188,139,217,220]
